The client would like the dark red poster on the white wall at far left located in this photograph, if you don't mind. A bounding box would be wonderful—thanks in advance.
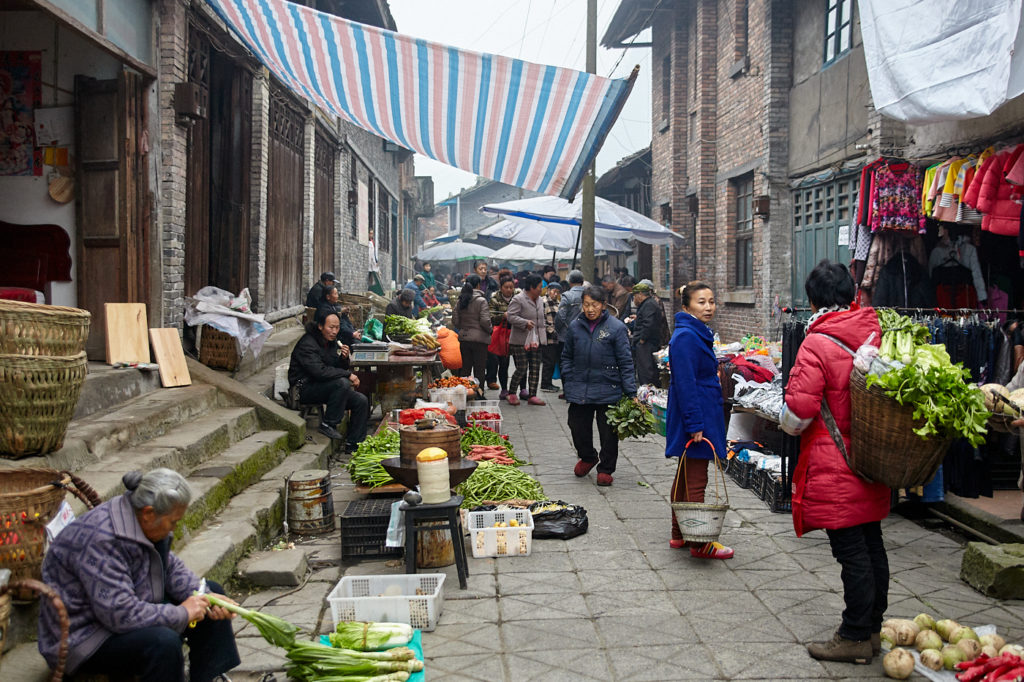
[0,51,43,175]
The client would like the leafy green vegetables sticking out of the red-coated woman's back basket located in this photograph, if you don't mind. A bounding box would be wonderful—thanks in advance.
[867,309,991,446]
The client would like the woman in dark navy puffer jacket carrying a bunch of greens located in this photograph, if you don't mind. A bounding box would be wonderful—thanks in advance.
[561,284,637,485]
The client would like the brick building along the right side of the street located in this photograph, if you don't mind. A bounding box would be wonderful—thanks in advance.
[602,0,1024,339]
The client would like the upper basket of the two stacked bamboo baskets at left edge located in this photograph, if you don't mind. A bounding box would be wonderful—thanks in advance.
[0,299,92,355]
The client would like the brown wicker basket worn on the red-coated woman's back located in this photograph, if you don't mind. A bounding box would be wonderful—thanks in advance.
[850,369,950,488]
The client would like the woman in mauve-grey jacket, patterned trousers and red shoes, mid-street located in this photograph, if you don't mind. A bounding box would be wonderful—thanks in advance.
[507,274,548,404]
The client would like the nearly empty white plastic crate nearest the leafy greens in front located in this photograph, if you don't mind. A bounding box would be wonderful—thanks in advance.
[327,573,444,632]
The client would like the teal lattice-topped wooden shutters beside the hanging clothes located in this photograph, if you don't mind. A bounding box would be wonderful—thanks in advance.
[792,175,858,307]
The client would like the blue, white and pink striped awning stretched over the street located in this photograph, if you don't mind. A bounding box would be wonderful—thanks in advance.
[207,0,636,198]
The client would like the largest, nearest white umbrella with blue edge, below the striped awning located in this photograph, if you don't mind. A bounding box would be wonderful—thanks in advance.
[480,195,682,242]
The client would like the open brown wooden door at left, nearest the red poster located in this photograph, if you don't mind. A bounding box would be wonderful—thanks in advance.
[75,72,150,359]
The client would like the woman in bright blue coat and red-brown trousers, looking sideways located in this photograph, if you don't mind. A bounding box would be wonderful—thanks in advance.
[665,282,732,559]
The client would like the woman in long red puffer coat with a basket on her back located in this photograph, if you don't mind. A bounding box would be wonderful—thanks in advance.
[780,260,890,664]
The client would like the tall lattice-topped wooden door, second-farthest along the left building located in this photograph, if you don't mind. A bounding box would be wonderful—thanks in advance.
[263,89,306,312]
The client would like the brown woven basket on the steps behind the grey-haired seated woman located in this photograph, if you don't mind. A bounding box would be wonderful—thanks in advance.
[0,467,72,581]
